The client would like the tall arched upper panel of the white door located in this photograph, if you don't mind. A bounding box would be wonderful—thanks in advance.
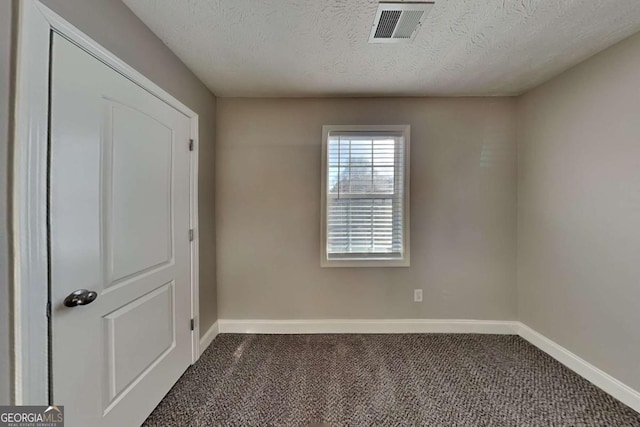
[110,102,173,283]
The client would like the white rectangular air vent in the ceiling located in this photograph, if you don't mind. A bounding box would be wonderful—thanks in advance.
[369,2,433,43]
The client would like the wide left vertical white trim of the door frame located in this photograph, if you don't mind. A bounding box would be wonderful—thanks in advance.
[12,1,50,405]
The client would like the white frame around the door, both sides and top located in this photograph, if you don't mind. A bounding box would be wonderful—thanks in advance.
[12,0,200,405]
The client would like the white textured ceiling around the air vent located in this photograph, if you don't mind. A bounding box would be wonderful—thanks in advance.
[123,0,640,96]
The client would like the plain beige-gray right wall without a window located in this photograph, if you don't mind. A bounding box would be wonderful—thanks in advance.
[518,30,640,390]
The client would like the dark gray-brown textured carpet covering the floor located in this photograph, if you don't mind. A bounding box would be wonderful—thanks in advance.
[145,334,640,427]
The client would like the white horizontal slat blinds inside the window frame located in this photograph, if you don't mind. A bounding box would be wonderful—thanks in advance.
[326,132,405,260]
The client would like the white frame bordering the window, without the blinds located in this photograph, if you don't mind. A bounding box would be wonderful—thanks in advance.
[320,125,411,267]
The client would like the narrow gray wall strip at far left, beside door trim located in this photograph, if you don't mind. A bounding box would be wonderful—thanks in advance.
[0,1,14,405]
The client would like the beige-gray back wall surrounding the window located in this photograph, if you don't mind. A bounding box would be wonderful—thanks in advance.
[216,98,516,319]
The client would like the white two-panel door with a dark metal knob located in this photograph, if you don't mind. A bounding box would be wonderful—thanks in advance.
[49,35,192,427]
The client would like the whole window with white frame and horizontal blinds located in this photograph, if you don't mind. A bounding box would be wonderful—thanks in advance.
[321,125,409,267]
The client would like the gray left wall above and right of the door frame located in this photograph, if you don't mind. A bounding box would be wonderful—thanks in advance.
[44,0,217,335]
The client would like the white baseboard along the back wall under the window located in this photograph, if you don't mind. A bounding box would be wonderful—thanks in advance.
[218,319,518,335]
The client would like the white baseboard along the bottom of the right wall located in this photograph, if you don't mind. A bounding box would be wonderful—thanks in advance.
[517,322,640,412]
